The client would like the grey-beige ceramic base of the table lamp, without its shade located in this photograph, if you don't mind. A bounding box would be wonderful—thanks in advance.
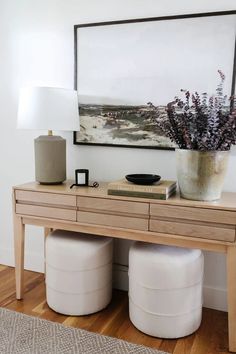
[34,135,66,184]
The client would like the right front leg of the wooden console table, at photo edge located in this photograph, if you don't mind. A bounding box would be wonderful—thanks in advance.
[227,246,236,352]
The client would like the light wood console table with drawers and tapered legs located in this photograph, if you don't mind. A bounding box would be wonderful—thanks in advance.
[13,181,236,352]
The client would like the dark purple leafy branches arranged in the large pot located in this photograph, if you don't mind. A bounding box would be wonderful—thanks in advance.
[149,70,236,151]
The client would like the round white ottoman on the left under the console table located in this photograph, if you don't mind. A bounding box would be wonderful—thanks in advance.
[45,230,112,315]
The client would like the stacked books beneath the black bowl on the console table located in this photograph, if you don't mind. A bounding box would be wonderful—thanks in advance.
[107,179,176,200]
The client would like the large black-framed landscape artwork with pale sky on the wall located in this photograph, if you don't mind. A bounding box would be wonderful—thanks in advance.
[74,11,236,149]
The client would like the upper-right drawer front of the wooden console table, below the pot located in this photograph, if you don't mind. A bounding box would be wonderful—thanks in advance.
[150,203,236,225]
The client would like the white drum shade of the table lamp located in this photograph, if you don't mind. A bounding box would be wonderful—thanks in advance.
[17,87,80,131]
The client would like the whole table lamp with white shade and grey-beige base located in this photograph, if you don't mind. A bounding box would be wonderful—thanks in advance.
[17,87,80,184]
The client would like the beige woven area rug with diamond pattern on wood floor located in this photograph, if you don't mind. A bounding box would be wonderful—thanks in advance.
[0,308,166,354]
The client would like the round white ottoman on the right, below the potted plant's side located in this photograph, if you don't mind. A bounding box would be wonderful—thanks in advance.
[129,242,204,338]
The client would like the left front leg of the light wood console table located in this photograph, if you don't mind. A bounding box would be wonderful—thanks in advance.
[14,215,25,300]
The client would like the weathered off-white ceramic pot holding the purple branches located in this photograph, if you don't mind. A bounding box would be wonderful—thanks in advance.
[176,149,229,201]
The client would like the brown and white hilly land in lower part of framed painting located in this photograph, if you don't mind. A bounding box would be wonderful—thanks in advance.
[75,104,175,149]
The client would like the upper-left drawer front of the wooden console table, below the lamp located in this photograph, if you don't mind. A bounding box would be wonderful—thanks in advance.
[15,190,76,207]
